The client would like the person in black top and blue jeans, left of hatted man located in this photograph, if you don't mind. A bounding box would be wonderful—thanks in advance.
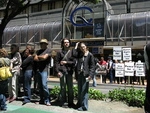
[21,47,34,105]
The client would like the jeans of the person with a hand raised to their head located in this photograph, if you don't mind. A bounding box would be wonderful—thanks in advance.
[78,73,89,110]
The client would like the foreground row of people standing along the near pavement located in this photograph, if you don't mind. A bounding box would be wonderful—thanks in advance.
[0,38,95,111]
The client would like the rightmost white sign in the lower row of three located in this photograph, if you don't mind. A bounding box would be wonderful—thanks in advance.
[135,62,145,76]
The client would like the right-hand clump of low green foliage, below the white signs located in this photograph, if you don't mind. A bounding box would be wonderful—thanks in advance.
[108,88,145,107]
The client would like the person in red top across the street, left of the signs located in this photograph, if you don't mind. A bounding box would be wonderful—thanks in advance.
[99,57,107,83]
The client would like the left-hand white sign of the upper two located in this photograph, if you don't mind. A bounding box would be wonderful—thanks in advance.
[113,47,122,60]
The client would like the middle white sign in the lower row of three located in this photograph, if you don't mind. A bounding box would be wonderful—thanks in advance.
[124,62,134,76]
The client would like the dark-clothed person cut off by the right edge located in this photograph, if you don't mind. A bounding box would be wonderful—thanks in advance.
[144,43,150,113]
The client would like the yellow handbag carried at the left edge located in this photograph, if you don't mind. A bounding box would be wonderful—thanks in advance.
[0,60,12,80]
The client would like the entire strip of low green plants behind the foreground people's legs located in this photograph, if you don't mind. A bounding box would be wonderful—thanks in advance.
[51,86,145,107]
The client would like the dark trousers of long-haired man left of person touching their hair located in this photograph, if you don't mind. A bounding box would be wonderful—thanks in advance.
[60,72,74,105]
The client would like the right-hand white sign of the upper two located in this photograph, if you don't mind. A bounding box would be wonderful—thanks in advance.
[122,48,132,61]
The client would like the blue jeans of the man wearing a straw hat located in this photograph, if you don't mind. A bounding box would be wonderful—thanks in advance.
[37,71,50,104]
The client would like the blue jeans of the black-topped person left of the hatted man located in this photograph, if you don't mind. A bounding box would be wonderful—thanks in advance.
[24,70,32,102]
